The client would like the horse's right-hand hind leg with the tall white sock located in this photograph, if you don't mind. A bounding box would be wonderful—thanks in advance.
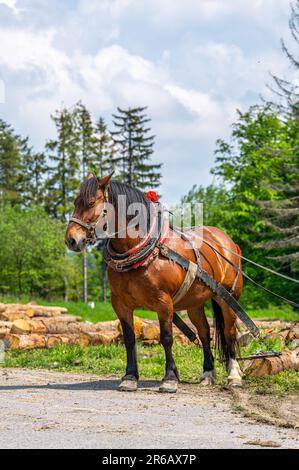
[212,299,242,387]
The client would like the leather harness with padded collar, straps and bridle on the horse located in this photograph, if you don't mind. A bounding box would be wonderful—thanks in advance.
[70,195,288,359]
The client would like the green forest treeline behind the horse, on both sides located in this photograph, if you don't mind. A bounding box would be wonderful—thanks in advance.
[0,0,299,305]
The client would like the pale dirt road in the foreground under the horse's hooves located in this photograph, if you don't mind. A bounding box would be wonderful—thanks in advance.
[0,369,299,449]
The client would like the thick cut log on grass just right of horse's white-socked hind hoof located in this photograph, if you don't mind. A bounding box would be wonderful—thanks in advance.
[244,348,299,377]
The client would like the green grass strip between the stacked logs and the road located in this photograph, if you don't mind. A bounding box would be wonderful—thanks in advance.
[2,342,299,394]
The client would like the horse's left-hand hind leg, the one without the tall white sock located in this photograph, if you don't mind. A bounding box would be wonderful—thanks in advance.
[188,306,215,385]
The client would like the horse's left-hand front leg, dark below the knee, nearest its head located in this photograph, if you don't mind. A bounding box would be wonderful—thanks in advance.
[111,297,139,392]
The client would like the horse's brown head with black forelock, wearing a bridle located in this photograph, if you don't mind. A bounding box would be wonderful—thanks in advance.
[65,173,112,252]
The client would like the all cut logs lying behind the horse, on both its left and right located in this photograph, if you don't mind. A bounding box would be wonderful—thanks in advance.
[0,303,299,376]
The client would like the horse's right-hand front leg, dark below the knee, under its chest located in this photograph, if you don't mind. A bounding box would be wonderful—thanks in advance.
[157,302,179,393]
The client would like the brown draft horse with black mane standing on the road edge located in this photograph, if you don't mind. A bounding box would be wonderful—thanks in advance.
[65,174,242,392]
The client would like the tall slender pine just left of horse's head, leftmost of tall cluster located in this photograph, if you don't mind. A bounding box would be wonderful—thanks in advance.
[46,108,80,221]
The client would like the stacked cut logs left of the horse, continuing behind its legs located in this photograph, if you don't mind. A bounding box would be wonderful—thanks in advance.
[0,304,192,349]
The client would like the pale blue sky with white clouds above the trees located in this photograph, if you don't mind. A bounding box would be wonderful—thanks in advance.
[0,0,296,203]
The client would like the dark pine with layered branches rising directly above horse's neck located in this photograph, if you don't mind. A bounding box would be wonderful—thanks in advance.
[111,107,162,190]
